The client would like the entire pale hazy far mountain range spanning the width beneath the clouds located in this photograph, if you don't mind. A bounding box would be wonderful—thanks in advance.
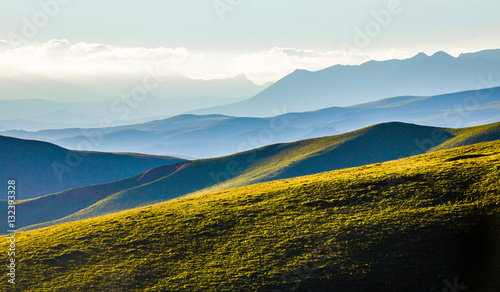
[0,50,500,131]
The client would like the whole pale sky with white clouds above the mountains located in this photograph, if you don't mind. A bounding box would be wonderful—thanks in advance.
[0,0,500,84]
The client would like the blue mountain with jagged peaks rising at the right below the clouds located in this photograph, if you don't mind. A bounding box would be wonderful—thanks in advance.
[192,50,500,117]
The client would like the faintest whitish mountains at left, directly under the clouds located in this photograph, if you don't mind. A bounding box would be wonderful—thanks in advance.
[0,68,271,102]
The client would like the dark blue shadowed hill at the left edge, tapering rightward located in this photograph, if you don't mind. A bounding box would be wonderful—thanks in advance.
[0,136,183,199]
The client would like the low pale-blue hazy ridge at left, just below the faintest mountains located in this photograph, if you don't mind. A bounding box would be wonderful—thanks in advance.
[0,96,250,131]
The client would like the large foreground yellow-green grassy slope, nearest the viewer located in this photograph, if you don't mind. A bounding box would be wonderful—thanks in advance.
[0,141,500,292]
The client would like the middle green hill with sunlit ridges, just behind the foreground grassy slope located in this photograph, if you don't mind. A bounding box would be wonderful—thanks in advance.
[19,123,500,232]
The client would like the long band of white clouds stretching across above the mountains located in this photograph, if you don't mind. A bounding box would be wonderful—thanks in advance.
[0,39,415,84]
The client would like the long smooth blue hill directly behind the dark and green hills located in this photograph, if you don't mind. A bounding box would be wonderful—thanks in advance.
[4,87,500,158]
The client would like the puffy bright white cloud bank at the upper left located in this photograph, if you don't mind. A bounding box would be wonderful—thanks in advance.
[0,39,200,75]
